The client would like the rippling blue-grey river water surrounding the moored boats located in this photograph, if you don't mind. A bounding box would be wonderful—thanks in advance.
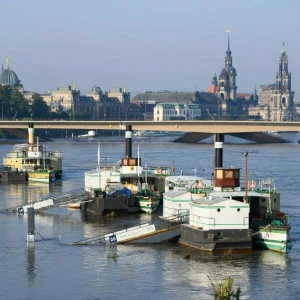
[0,135,300,300]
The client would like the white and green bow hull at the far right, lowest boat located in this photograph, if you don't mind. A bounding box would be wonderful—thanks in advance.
[252,227,292,253]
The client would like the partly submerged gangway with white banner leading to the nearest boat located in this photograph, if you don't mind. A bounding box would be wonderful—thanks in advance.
[73,212,189,246]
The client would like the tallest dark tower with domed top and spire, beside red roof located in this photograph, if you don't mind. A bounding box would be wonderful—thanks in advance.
[219,30,237,101]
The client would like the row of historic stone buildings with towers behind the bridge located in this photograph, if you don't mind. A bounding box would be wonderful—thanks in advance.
[0,33,300,121]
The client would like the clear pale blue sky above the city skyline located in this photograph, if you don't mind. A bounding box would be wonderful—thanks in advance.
[0,0,300,100]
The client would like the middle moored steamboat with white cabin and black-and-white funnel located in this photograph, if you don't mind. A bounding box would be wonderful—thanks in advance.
[85,125,170,214]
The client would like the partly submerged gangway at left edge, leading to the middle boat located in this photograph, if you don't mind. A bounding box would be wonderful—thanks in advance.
[0,188,91,214]
